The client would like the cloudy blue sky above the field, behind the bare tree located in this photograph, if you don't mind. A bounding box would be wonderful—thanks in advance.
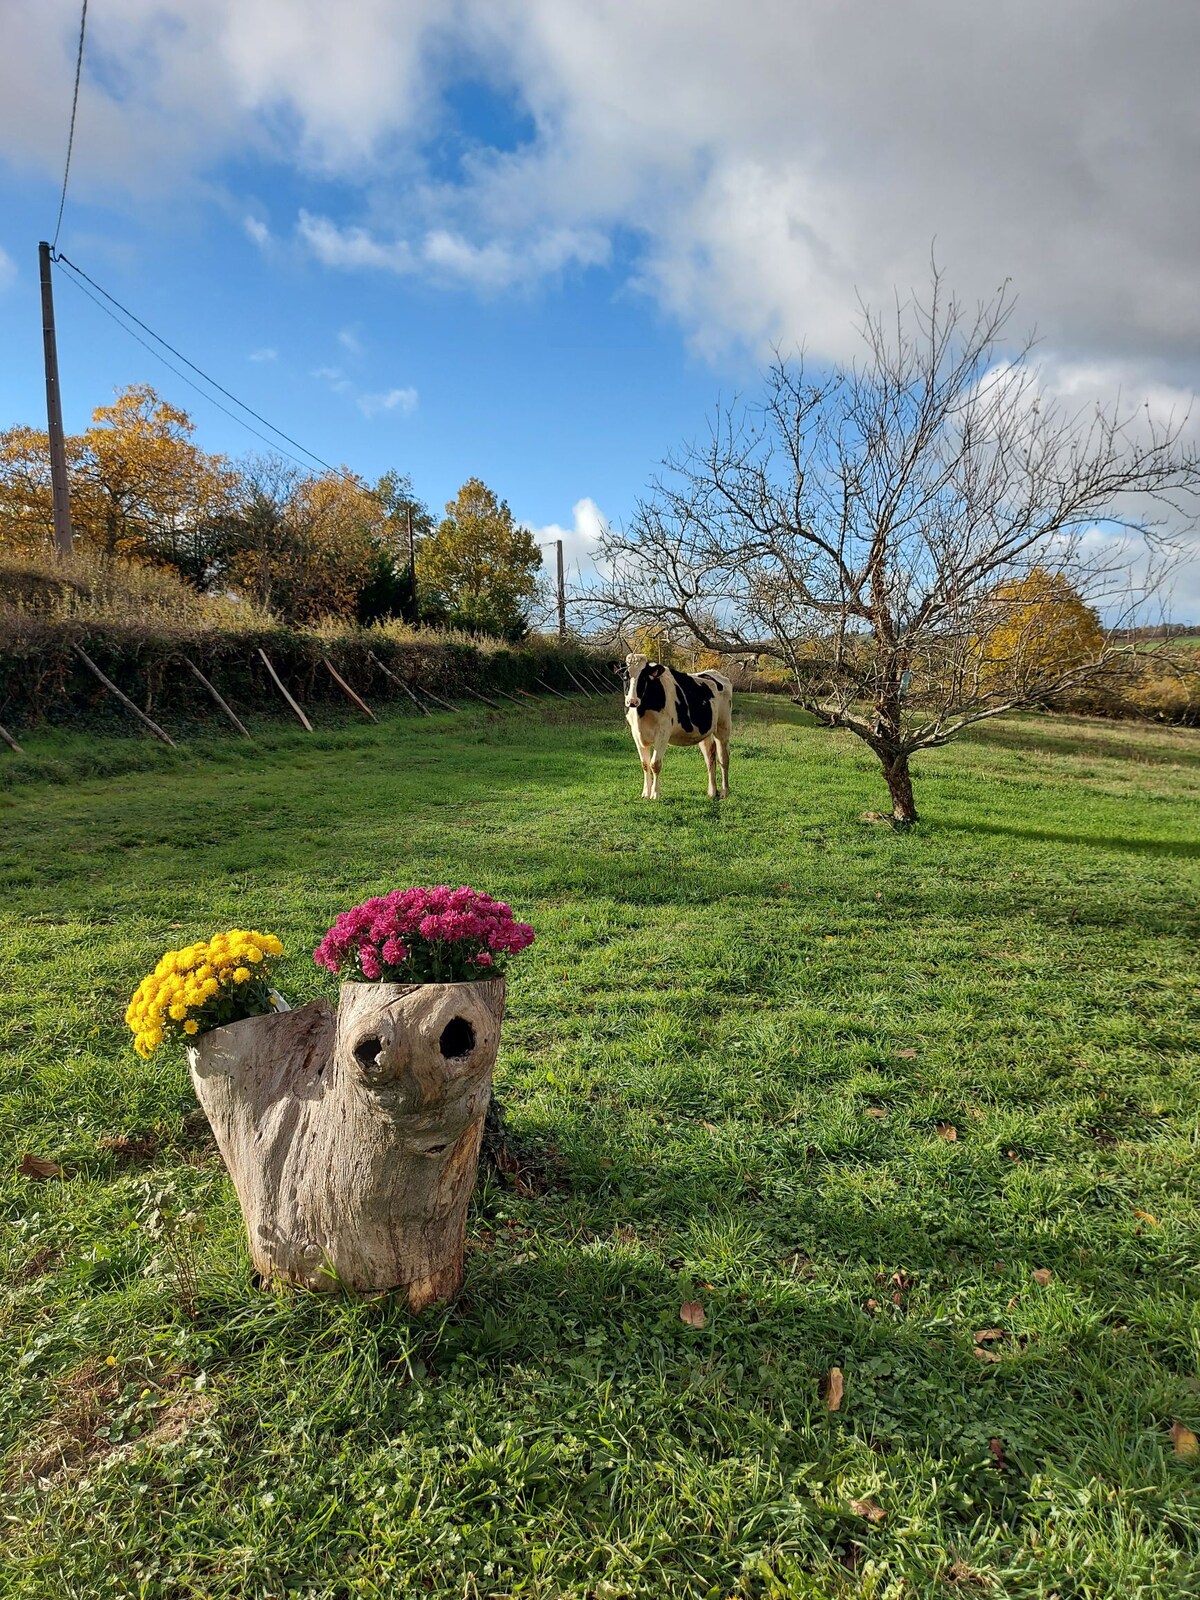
[0,0,1200,614]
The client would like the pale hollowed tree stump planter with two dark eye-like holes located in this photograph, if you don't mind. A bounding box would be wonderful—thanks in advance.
[187,979,504,1310]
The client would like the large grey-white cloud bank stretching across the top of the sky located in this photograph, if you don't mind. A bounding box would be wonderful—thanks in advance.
[0,0,1200,372]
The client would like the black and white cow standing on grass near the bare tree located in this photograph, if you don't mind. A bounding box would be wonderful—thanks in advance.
[622,654,733,800]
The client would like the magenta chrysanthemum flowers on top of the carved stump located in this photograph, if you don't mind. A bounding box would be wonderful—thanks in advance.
[312,883,534,982]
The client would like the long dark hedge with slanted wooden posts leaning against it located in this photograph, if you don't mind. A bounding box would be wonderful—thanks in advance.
[0,616,611,733]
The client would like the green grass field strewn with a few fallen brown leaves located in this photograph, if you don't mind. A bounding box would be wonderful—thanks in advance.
[0,701,1200,1600]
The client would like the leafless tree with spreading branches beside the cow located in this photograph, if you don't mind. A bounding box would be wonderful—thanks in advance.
[590,267,1200,824]
